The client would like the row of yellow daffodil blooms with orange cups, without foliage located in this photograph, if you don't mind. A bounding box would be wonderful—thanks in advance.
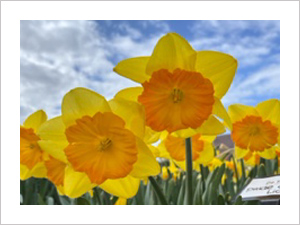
[20,33,280,202]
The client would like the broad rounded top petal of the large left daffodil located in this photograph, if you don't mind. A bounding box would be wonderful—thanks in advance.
[61,88,111,127]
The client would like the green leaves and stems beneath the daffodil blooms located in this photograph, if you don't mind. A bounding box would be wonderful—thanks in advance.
[20,159,278,205]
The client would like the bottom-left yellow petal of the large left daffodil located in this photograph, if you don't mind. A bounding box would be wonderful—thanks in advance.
[64,166,95,198]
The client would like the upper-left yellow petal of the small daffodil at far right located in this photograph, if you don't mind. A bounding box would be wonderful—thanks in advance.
[228,104,259,123]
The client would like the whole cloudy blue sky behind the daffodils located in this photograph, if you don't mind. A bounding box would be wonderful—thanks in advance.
[20,20,280,123]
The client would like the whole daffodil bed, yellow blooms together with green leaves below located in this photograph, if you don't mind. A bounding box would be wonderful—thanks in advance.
[20,33,280,205]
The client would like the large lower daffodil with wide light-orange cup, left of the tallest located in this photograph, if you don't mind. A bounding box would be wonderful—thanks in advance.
[41,88,160,198]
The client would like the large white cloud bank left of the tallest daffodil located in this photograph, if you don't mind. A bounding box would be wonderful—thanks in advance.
[20,21,166,123]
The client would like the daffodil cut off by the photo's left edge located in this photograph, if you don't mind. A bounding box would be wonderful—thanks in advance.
[20,110,48,180]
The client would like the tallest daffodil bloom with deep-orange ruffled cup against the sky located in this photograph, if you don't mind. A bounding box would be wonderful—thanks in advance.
[114,33,237,137]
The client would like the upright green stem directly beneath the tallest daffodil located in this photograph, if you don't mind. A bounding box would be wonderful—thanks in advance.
[185,138,193,205]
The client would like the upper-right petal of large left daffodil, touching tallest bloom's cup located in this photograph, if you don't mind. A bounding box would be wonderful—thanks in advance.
[109,98,145,138]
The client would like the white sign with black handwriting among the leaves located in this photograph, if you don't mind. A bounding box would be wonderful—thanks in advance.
[240,176,280,200]
